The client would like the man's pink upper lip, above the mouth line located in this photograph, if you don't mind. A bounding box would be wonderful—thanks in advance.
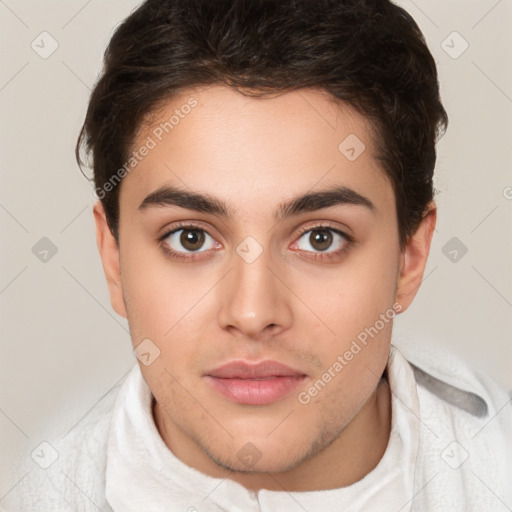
[206,360,305,379]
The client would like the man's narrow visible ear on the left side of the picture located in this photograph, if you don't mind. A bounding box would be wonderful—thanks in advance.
[93,201,127,318]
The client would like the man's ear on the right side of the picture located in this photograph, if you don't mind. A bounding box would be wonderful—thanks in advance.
[396,202,437,313]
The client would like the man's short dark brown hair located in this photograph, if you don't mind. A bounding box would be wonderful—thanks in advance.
[76,0,448,247]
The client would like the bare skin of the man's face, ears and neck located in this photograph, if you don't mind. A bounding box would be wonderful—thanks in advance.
[94,85,436,491]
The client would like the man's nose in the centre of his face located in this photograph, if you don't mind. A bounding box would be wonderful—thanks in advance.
[219,244,292,340]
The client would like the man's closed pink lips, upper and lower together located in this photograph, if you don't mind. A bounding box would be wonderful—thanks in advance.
[205,360,306,405]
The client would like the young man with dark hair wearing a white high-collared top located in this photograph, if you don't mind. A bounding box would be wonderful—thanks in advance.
[2,0,512,512]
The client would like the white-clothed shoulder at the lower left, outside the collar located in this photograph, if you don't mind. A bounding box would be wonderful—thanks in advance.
[0,374,124,512]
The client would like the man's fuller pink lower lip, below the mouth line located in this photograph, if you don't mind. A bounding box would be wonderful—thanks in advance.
[206,375,306,405]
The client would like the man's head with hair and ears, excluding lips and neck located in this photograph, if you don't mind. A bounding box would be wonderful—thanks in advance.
[77,0,447,480]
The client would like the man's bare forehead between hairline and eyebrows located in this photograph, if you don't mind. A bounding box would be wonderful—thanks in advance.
[121,85,394,216]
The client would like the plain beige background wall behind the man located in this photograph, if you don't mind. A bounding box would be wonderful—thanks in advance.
[0,0,512,499]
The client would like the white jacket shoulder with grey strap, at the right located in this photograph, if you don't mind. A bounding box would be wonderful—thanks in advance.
[399,342,512,511]
